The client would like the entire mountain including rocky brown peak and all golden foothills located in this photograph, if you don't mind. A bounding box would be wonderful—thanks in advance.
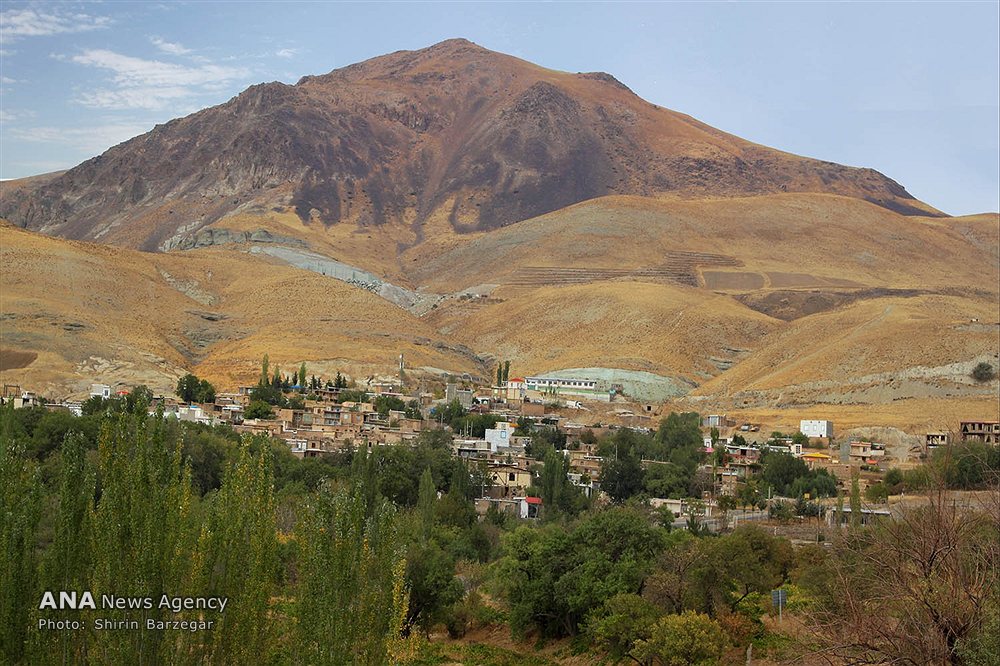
[0,40,1000,432]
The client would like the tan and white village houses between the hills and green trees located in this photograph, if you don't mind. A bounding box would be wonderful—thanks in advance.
[2,376,1000,518]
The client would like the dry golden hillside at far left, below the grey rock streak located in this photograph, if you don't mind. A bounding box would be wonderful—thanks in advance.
[0,224,478,396]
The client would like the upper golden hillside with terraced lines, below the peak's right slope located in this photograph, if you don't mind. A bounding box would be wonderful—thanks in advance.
[401,194,1000,293]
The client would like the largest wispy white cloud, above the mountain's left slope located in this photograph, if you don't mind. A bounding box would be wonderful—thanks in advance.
[70,49,248,109]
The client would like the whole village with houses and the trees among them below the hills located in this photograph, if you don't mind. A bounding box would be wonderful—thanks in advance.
[3,360,1000,530]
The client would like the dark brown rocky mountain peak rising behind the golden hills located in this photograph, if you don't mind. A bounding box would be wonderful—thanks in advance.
[0,39,938,250]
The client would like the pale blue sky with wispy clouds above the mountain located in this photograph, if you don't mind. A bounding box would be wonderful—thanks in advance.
[0,0,1000,214]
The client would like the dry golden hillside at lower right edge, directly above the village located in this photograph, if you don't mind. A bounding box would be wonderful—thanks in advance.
[694,295,1000,400]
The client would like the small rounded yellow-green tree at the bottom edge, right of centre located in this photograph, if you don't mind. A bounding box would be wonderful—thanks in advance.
[635,611,727,666]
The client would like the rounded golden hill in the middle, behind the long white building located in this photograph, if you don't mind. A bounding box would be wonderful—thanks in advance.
[427,281,781,388]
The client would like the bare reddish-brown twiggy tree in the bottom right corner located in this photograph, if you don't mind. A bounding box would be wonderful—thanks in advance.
[809,486,1000,664]
